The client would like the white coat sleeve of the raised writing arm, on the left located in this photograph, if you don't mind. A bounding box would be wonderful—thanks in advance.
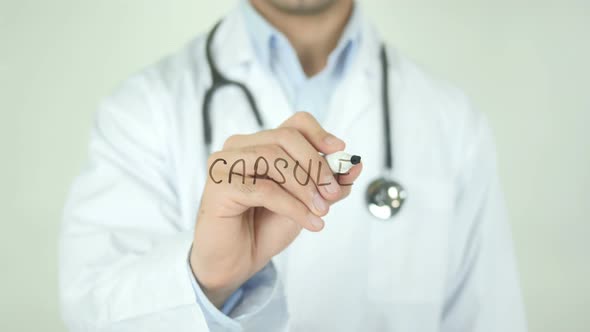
[60,76,284,332]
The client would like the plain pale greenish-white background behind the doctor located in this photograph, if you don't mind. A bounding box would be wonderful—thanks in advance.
[0,0,590,332]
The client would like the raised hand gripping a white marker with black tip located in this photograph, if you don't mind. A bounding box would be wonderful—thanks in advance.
[189,112,363,308]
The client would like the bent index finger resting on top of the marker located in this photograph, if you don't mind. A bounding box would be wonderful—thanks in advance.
[279,112,346,154]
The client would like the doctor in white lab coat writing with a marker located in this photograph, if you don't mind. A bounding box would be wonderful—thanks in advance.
[60,0,526,332]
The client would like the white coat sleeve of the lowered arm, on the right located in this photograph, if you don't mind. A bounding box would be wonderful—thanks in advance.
[442,107,526,332]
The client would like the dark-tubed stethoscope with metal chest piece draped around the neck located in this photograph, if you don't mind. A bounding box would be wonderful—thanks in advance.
[202,21,407,220]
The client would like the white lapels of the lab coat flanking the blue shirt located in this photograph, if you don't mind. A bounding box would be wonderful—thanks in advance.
[213,3,381,130]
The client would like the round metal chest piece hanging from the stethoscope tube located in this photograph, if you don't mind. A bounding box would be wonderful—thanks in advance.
[365,177,407,220]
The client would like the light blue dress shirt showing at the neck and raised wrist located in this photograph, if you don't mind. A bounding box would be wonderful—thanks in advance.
[188,0,361,330]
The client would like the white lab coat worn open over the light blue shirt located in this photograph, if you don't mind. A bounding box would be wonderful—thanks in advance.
[60,5,526,332]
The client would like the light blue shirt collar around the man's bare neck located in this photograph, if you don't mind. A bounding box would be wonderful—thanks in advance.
[240,0,362,77]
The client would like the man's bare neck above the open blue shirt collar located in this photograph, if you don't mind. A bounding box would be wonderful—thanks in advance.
[250,0,353,76]
